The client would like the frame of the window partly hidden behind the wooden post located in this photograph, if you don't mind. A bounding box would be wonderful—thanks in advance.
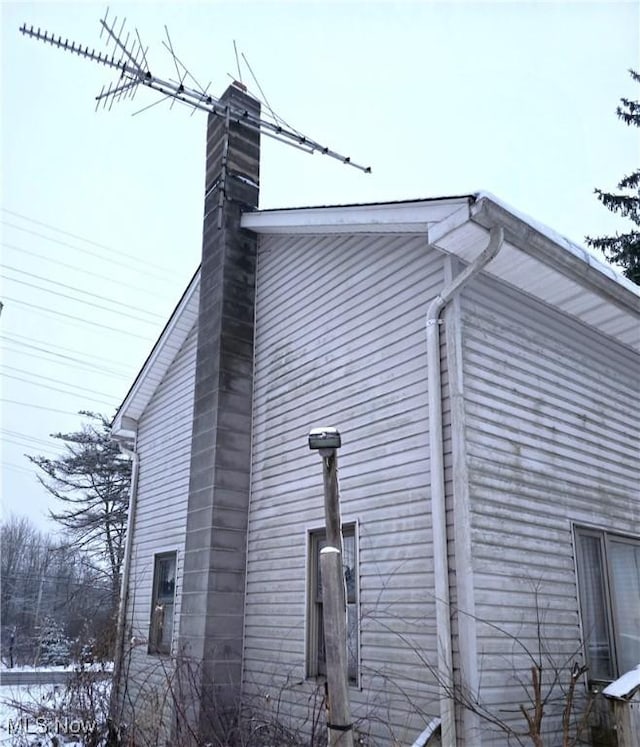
[305,521,360,688]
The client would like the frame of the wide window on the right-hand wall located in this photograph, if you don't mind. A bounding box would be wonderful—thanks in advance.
[573,524,640,682]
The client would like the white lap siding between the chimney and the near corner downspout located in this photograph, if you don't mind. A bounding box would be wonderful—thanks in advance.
[244,235,442,744]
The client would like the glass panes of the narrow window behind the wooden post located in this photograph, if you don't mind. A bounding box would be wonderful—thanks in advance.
[307,524,359,684]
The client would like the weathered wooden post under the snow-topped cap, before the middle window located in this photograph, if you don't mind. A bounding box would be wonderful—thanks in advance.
[320,449,353,747]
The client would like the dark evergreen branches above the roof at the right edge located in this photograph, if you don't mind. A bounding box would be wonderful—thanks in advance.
[586,70,640,285]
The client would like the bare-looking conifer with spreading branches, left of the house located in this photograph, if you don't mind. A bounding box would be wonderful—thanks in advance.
[28,412,131,613]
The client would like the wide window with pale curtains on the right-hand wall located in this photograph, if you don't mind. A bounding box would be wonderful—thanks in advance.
[576,528,640,680]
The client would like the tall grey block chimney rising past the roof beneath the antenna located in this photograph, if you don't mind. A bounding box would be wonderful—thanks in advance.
[179,84,260,737]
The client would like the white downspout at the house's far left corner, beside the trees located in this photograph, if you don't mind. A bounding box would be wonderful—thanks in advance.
[109,434,140,728]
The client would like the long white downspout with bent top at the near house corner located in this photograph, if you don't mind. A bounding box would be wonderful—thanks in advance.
[426,226,504,747]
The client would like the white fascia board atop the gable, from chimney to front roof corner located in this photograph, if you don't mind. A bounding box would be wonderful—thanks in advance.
[241,197,471,234]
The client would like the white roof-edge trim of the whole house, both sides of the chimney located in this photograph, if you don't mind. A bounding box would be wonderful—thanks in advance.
[112,192,640,438]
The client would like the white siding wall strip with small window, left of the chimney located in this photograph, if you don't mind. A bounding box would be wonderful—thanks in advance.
[121,326,197,738]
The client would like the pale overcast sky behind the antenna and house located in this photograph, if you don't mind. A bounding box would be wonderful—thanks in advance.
[0,0,640,528]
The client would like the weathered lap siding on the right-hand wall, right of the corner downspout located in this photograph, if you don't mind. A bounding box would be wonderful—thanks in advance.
[463,280,640,744]
